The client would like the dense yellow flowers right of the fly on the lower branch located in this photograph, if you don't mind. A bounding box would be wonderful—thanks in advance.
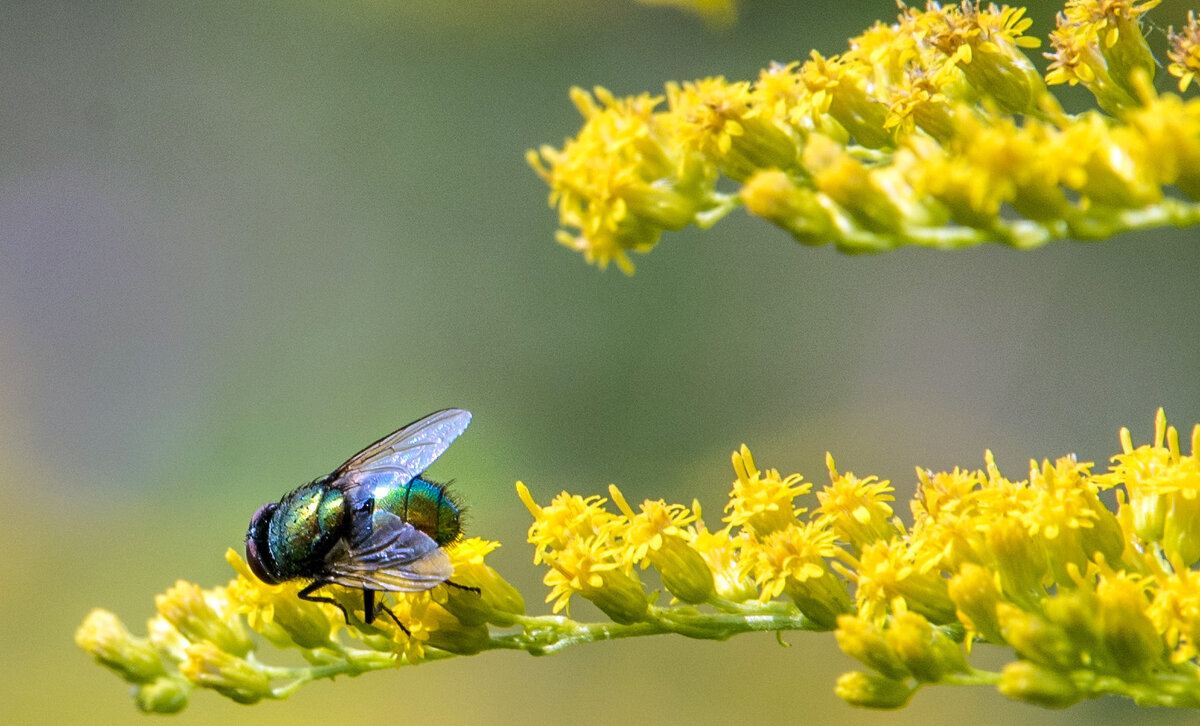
[517,412,1200,708]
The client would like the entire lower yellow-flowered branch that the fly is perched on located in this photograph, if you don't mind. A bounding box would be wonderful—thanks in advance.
[76,410,1200,713]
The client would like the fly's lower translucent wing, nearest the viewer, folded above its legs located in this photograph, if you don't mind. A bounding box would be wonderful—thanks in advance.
[322,511,454,593]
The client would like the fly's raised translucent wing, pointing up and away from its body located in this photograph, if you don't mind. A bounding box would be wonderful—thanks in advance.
[330,408,470,486]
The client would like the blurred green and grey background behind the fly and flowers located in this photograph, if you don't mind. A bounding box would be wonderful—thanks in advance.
[0,0,1200,726]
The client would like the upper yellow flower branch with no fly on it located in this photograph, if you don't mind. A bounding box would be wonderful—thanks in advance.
[528,0,1200,272]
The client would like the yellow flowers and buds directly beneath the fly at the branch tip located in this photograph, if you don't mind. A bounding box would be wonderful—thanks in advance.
[76,539,524,713]
